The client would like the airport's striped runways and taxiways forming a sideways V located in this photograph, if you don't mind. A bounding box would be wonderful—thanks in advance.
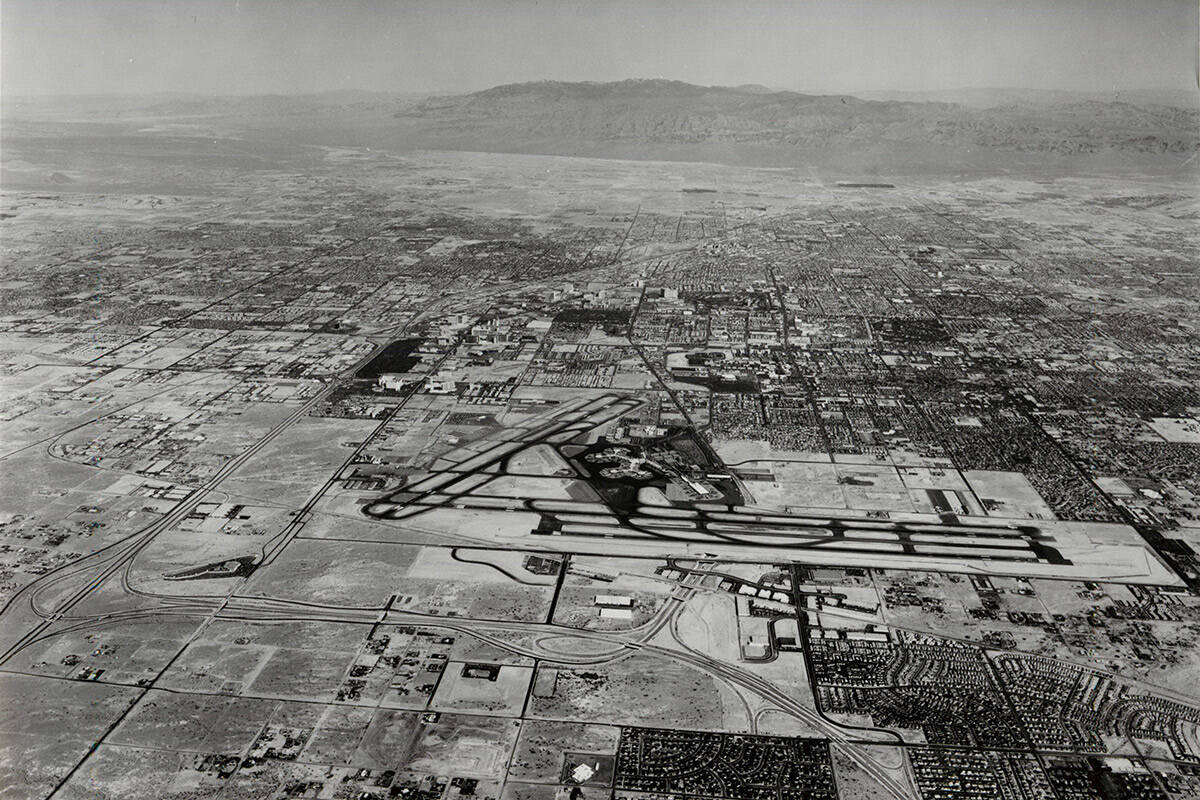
[364,395,1069,564]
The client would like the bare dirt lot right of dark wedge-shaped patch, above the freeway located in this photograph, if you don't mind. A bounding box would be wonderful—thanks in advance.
[242,539,419,607]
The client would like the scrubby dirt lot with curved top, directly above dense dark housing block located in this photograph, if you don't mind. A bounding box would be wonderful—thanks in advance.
[527,656,724,730]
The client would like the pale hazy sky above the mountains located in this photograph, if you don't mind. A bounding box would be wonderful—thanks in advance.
[0,0,1198,95]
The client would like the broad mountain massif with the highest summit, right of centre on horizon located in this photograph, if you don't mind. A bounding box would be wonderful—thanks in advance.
[395,79,1200,156]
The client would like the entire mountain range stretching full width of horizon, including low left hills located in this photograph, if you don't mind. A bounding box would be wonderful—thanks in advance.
[4,79,1200,175]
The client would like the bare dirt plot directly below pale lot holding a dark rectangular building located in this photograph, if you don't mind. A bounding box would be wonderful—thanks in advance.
[404,714,521,780]
